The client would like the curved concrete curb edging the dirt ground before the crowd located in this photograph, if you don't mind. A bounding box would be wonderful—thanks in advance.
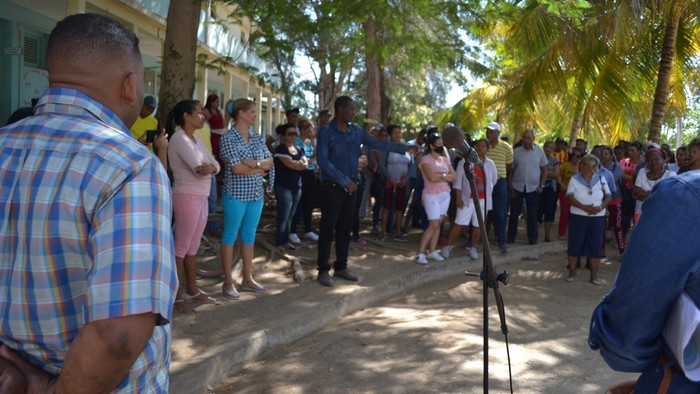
[170,241,566,394]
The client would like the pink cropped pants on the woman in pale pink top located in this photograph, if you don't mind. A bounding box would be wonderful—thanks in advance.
[173,193,209,257]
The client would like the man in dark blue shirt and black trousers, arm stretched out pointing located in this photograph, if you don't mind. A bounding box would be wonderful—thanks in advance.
[316,96,406,287]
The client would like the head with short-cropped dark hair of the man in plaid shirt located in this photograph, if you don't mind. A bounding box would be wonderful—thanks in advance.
[47,13,143,126]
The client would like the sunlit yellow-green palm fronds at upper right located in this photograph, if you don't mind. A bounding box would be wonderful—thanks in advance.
[441,0,700,143]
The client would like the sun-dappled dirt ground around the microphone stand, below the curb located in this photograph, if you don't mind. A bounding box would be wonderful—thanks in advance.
[214,249,636,393]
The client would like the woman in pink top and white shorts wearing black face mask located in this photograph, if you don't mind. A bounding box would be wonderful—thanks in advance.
[413,132,457,264]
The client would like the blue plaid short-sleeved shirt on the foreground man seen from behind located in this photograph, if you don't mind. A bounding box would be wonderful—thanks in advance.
[0,89,177,393]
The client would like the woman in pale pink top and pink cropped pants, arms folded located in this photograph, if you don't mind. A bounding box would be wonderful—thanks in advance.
[166,100,220,314]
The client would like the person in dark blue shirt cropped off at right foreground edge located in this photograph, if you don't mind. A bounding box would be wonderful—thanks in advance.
[588,171,700,393]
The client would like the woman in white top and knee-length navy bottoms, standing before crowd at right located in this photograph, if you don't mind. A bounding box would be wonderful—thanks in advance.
[566,155,612,286]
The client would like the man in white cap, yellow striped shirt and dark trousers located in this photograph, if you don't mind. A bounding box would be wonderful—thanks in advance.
[486,122,513,253]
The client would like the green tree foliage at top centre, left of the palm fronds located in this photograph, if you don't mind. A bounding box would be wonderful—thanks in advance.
[228,0,484,122]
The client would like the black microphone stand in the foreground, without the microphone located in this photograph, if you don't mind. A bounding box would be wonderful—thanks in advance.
[464,155,513,393]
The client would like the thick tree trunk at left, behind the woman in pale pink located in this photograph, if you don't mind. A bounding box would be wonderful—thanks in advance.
[157,0,202,127]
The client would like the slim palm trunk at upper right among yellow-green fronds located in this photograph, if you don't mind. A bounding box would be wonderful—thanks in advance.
[649,7,681,143]
